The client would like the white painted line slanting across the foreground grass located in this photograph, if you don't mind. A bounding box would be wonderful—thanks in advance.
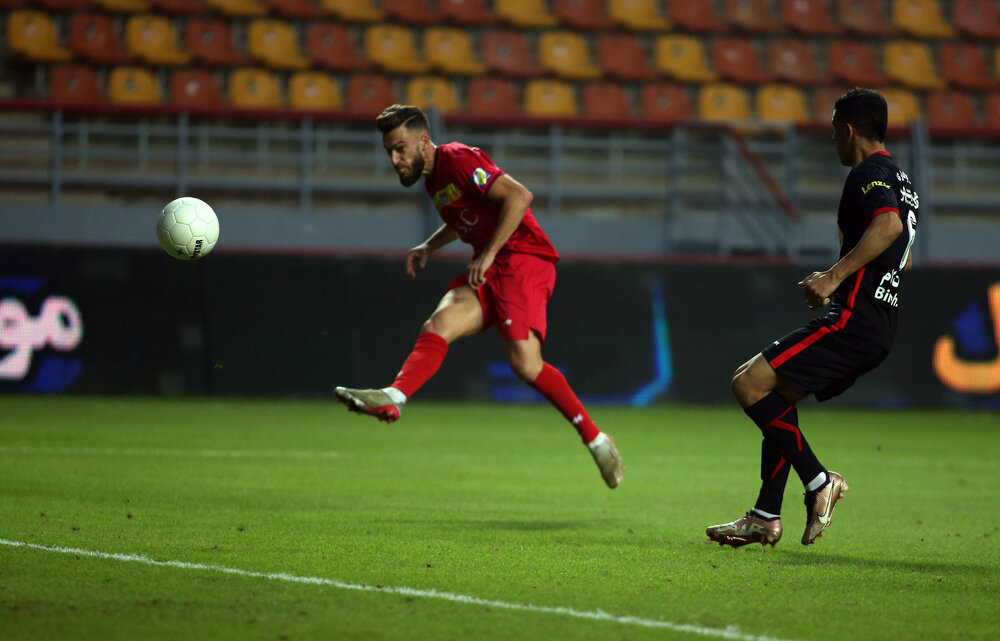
[0,539,804,641]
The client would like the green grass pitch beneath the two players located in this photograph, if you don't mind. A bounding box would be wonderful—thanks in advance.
[0,396,1000,641]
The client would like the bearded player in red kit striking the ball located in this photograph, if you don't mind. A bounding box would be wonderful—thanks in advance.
[336,105,625,488]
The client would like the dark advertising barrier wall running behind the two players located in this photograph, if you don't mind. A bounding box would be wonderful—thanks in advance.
[0,246,1000,408]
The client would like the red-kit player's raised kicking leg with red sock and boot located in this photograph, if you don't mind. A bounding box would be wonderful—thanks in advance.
[336,285,483,423]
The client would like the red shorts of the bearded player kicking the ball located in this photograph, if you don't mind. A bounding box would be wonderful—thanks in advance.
[448,253,556,343]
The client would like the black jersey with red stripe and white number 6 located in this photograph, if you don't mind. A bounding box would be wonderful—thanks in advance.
[824,151,920,350]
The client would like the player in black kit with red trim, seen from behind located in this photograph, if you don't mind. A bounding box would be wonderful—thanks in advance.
[705,89,920,547]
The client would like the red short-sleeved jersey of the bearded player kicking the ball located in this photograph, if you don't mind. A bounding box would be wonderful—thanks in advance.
[424,142,559,262]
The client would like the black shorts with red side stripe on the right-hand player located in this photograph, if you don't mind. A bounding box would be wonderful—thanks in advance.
[761,320,889,401]
